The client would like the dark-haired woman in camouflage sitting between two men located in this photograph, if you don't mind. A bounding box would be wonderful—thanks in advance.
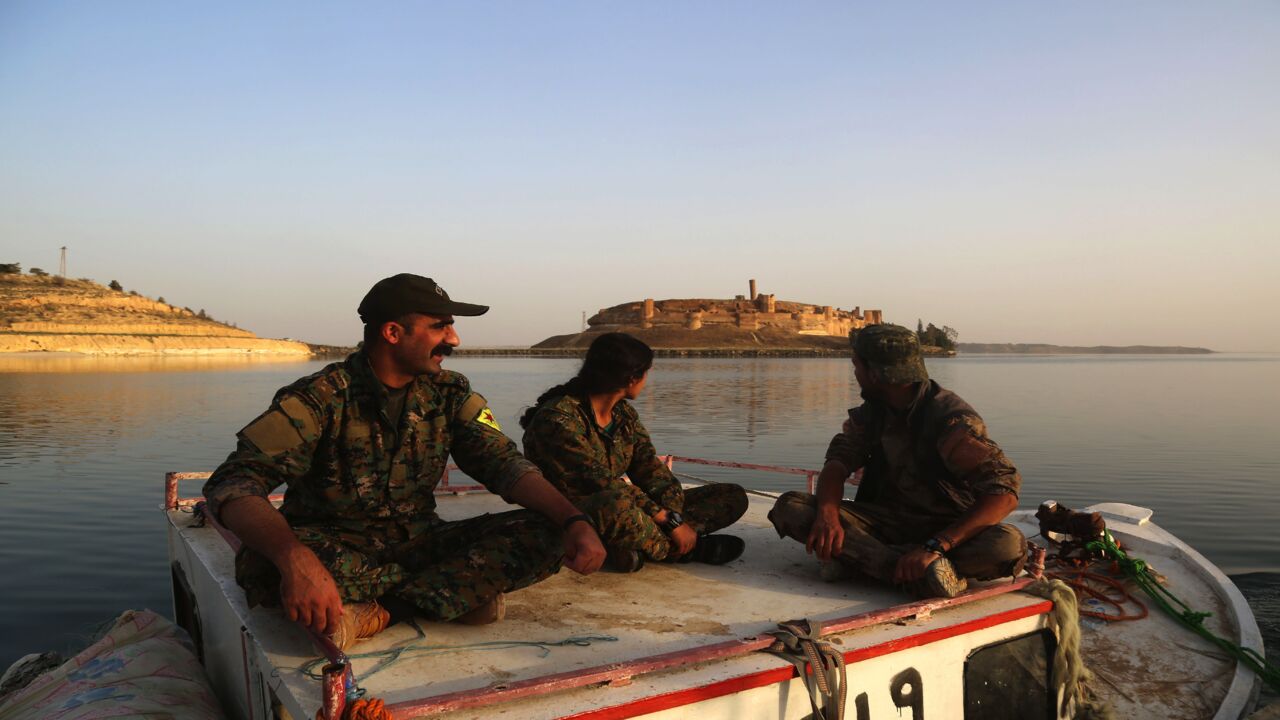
[520,333,746,573]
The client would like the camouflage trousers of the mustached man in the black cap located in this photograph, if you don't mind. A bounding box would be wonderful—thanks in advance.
[236,510,563,620]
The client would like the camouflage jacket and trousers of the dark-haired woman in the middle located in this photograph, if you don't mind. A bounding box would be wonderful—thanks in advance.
[524,395,746,560]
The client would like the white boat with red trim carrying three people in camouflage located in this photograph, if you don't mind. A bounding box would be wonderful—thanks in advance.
[164,456,1262,720]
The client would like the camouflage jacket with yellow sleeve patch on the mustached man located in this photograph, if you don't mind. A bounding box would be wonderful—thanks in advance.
[205,352,536,537]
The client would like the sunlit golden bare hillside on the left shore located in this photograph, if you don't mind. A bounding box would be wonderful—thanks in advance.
[0,274,310,355]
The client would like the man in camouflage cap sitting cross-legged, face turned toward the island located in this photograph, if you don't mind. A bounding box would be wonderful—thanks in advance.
[769,324,1027,597]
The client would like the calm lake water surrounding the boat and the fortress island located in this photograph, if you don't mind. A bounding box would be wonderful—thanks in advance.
[0,355,1280,670]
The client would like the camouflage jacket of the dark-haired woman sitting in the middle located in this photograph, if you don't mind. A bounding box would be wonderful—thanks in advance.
[524,395,685,515]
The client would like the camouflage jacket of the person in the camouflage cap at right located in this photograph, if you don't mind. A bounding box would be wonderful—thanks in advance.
[827,380,1021,520]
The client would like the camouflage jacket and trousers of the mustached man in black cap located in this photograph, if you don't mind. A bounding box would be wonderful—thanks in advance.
[205,352,562,620]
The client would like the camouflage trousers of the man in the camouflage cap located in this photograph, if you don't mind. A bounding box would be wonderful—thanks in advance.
[769,491,1027,582]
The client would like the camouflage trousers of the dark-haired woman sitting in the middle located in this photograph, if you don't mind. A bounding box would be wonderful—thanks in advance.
[573,483,746,560]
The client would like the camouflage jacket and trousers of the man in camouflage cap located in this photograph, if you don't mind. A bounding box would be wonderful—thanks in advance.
[769,380,1025,579]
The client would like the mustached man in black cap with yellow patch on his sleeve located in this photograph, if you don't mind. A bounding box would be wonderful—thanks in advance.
[205,274,604,648]
